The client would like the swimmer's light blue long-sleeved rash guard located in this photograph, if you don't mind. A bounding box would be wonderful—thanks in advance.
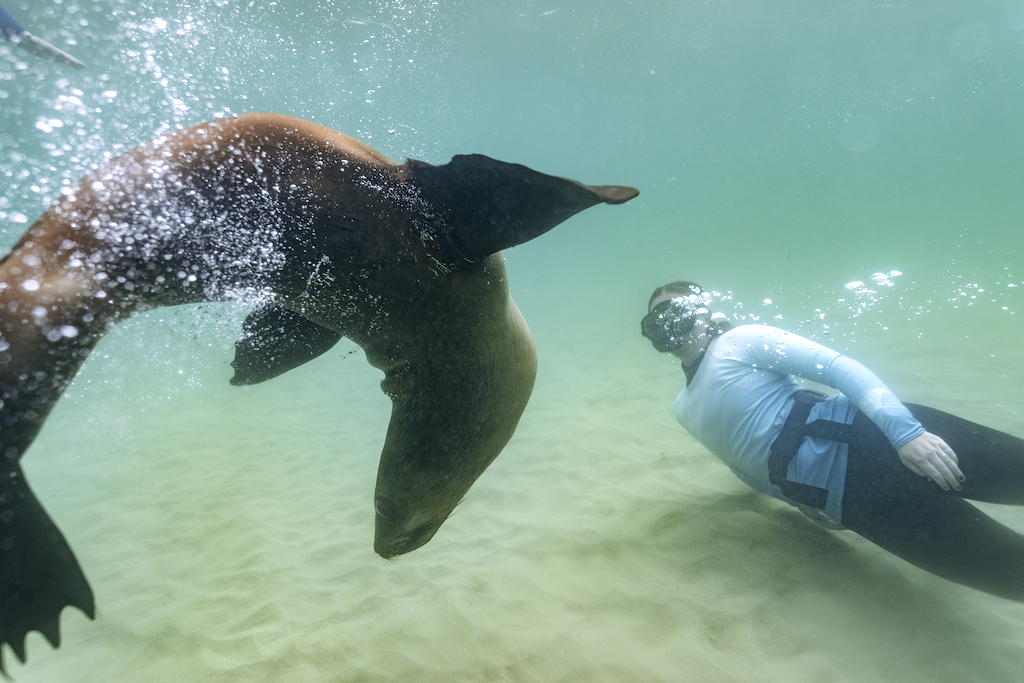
[675,325,925,522]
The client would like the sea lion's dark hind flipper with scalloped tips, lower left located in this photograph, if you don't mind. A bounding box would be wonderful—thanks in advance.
[0,465,96,675]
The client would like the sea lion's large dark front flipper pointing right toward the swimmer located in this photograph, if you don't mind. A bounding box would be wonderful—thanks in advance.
[403,155,640,262]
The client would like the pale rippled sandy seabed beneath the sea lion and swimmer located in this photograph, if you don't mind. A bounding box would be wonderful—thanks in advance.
[5,305,1024,683]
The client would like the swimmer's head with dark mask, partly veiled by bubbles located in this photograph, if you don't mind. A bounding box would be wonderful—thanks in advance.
[640,281,711,358]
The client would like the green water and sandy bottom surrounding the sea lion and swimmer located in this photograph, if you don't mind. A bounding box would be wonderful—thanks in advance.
[0,0,1024,683]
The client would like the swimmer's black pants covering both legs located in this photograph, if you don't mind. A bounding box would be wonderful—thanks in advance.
[843,403,1024,601]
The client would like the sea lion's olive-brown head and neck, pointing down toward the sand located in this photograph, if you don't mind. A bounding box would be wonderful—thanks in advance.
[364,254,537,557]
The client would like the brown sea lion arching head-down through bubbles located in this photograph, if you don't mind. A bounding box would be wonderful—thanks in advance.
[0,114,638,661]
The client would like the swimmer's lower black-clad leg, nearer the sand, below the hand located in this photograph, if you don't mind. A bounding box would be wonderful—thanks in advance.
[843,415,1024,601]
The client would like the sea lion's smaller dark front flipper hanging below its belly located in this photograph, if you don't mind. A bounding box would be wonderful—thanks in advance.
[230,304,343,386]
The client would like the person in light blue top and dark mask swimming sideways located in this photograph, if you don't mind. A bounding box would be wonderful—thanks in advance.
[641,282,1024,601]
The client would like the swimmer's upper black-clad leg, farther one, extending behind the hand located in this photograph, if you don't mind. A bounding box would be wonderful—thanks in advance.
[905,403,1024,505]
